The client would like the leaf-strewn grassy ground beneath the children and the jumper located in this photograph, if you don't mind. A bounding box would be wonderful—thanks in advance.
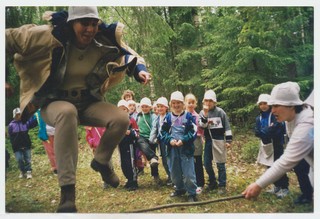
[5,133,313,213]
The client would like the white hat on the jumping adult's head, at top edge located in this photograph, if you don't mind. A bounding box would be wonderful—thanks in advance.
[67,6,100,22]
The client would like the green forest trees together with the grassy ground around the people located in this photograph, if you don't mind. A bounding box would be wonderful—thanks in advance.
[5,6,314,213]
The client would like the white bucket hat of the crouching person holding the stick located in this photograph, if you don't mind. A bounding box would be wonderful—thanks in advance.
[268,81,303,106]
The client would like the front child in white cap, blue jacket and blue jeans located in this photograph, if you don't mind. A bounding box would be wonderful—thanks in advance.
[161,91,197,202]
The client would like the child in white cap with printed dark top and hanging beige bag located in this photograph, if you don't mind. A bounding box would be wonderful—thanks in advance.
[199,90,232,194]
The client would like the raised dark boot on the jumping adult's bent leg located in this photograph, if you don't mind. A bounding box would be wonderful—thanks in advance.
[91,159,120,188]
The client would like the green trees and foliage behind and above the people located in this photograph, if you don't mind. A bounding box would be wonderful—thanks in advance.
[6,6,314,127]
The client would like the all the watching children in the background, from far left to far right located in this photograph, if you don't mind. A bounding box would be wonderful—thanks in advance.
[8,90,313,202]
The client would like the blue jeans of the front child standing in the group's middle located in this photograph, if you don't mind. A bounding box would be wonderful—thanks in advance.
[168,147,197,195]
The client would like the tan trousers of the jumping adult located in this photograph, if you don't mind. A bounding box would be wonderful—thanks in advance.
[41,101,129,186]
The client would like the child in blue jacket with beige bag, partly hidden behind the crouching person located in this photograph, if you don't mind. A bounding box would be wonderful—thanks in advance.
[255,94,289,198]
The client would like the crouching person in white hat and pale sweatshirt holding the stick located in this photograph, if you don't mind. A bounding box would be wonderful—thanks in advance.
[242,82,314,204]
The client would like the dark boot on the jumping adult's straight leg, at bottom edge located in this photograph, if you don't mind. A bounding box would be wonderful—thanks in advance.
[57,184,77,213]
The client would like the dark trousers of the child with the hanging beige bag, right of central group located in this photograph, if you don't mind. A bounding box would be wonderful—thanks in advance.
[203,139,227,187]
